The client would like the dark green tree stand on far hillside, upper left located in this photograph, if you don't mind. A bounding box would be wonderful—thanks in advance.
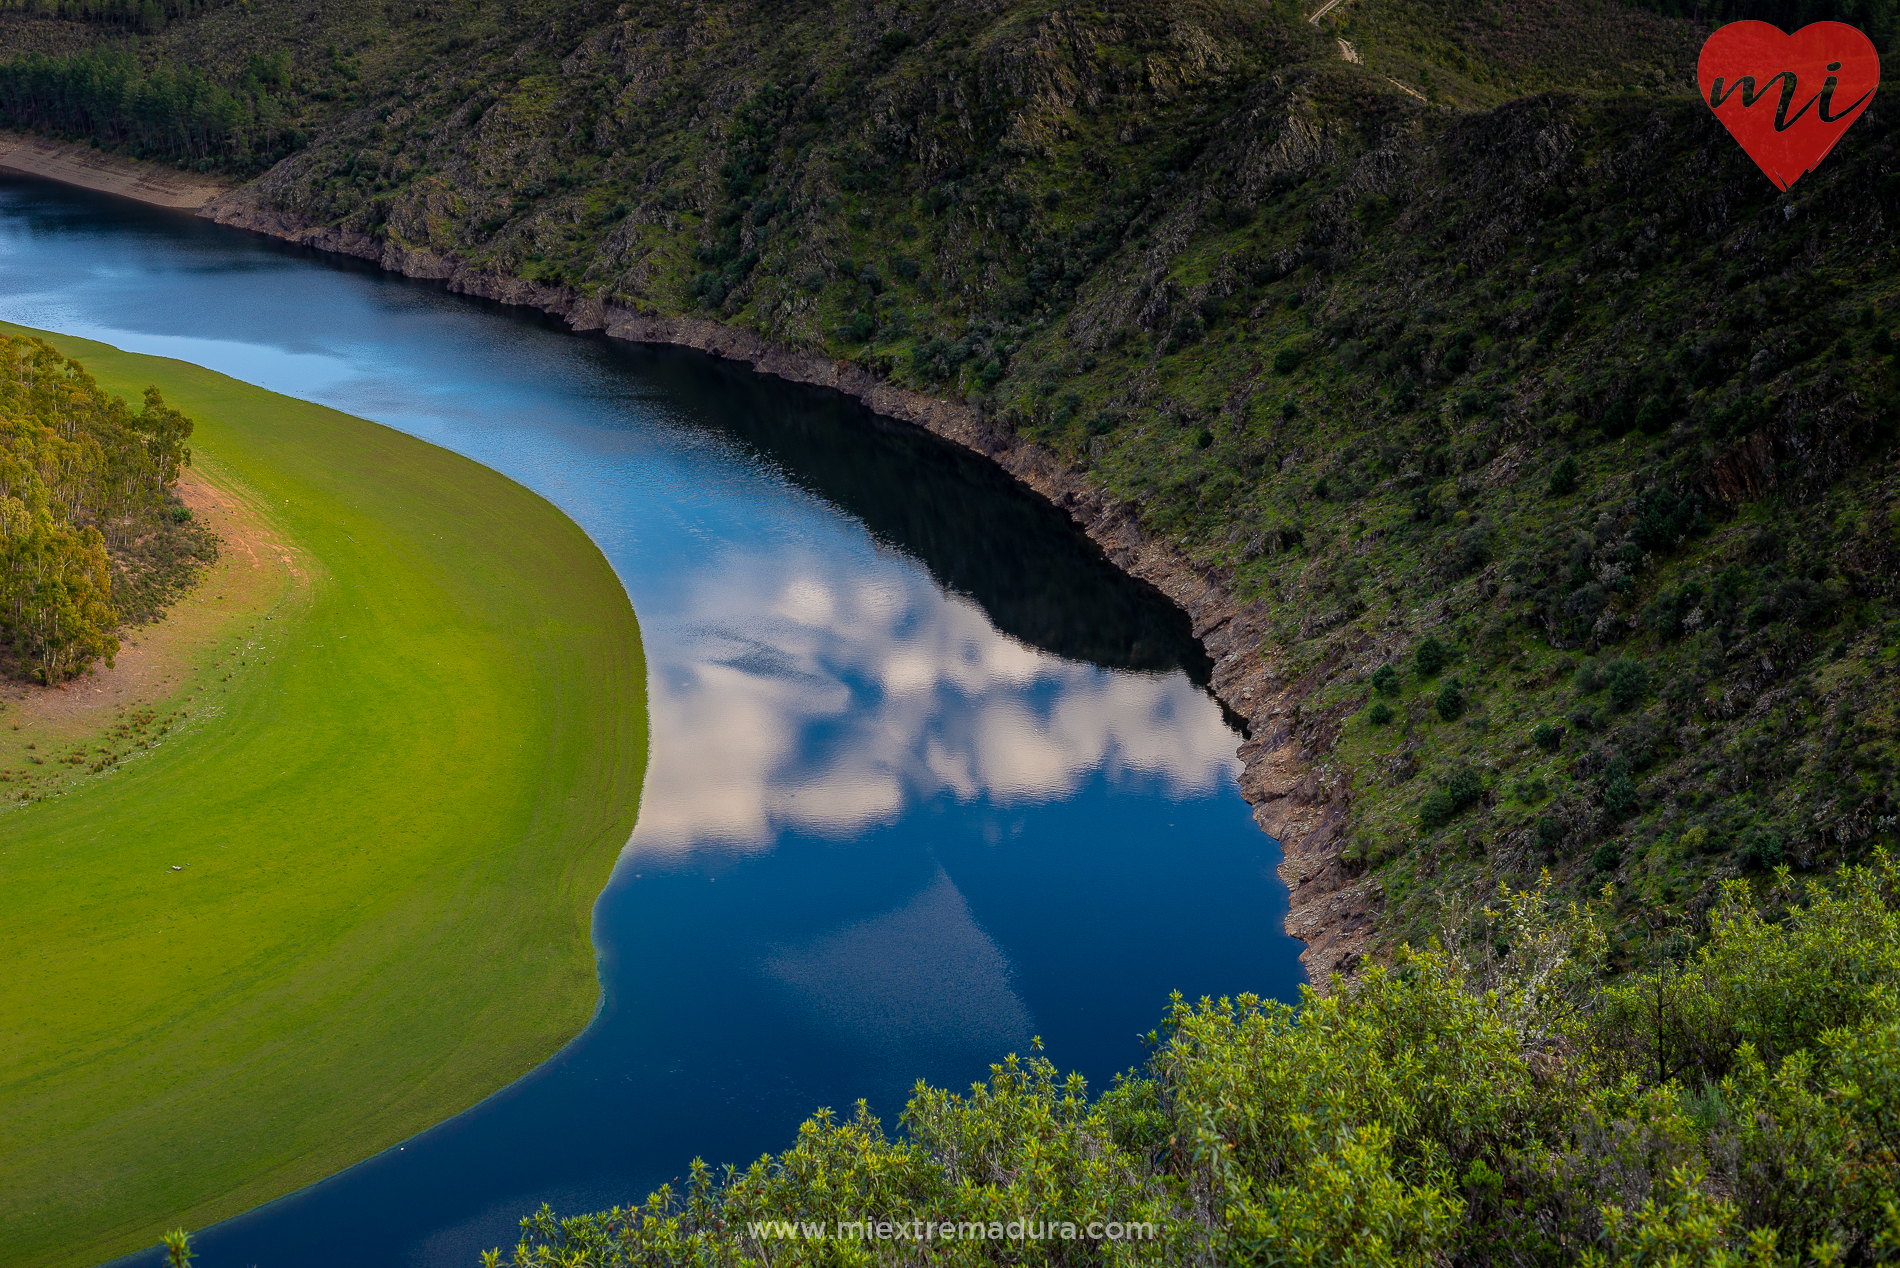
[0,49,304,171]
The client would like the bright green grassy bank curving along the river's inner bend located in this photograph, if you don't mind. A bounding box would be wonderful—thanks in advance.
[0,326,646,1264]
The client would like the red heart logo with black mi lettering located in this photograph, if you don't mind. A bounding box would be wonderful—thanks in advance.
[1695,23,1881,190]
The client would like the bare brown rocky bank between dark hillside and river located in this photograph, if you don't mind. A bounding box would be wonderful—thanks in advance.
[198,190,1379,985]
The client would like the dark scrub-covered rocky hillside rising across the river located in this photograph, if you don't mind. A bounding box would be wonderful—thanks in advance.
[0,0,1900,968]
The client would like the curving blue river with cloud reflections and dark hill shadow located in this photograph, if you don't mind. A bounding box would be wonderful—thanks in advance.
[0,179,1302,1268]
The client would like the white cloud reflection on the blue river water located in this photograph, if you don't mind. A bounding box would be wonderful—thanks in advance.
[631,549,1239,855]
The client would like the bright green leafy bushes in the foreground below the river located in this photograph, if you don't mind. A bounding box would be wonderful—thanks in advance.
[485,855,1900,1268]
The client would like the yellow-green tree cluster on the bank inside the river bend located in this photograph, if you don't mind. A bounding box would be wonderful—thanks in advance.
[0,335,192,686]
